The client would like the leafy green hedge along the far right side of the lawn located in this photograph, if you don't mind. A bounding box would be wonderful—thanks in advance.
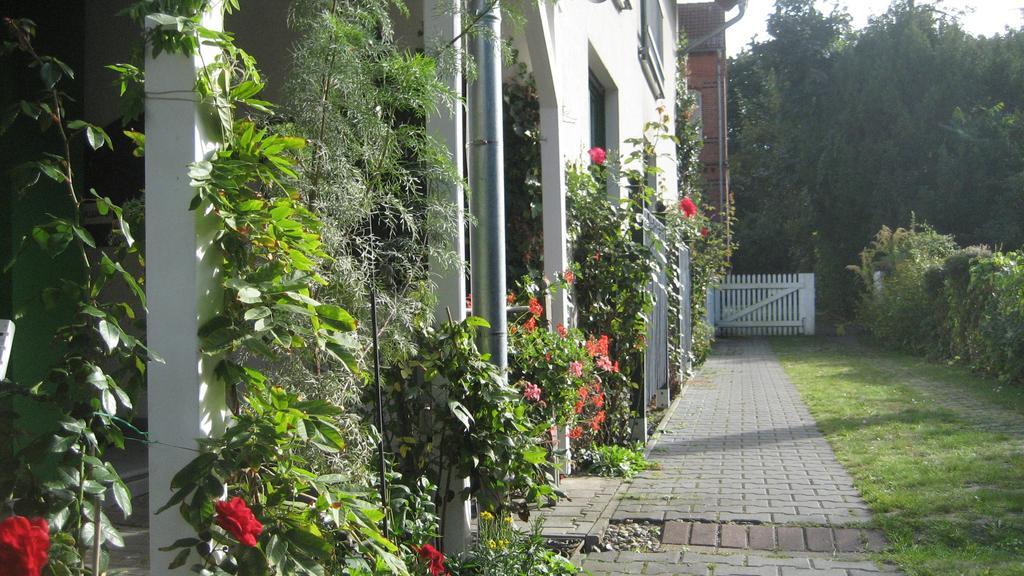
[850,223,1024,383]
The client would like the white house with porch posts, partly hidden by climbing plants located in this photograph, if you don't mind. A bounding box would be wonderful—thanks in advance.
[0,0,677,574]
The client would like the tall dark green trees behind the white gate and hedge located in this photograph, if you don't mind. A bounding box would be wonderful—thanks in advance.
[730,0,1024,319]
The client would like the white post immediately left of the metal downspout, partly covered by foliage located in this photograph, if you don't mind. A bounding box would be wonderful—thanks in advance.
[423,0,470,554]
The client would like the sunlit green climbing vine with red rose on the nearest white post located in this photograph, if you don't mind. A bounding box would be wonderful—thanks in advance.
[114,2,408,574]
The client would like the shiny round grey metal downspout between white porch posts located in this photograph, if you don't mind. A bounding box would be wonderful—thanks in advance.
[467,0,508,369]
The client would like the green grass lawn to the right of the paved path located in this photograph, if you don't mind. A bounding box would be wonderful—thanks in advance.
[771,338,1024,576]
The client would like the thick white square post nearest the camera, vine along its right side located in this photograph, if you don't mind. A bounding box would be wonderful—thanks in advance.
[145,3,228,576]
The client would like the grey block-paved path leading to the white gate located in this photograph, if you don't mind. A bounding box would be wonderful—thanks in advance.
[584,339,894,576]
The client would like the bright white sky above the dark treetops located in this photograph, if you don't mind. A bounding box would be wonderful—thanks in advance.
[720,0,1024,56]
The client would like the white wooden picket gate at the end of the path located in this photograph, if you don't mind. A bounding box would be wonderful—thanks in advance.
[708,274,814,336]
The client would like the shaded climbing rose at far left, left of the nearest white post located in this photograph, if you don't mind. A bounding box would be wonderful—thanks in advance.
[0,18,151,575]
